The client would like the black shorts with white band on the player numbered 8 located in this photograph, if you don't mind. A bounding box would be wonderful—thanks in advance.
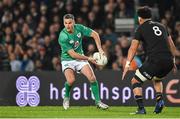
[135,59,173,82]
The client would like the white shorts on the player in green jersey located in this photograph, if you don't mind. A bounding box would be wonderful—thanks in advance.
[61,60,89,73]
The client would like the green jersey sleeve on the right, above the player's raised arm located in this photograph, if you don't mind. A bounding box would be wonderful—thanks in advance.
[77,24,93,37]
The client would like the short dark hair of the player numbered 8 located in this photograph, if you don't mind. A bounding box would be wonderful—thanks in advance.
[137,6,151,19]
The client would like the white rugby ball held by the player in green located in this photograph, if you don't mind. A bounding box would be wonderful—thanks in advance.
[93,52,108,66]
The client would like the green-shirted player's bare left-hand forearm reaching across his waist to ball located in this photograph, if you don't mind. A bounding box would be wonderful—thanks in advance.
[67,49,96,64]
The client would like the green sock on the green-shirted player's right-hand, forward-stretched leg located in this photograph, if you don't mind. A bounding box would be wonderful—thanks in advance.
[91,81,100,104]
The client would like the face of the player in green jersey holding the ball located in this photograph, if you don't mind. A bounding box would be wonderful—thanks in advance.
[64,19,74,32]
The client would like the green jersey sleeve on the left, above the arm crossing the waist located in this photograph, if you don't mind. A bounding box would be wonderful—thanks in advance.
[58,32,73,52]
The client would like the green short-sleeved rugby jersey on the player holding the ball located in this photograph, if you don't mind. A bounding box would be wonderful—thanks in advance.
[58,24,92,61]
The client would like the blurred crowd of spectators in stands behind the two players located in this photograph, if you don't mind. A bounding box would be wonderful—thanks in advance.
[0,0,180,71]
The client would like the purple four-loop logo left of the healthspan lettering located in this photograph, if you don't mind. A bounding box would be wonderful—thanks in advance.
[16,76,40,107]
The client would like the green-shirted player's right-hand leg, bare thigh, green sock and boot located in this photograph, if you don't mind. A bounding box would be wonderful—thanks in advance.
[81,64,109,109]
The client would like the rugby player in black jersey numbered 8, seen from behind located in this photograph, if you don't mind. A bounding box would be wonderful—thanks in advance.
[122,6,177,114]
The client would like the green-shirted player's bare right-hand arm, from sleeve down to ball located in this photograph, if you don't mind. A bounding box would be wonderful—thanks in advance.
[91,30,104,55]
